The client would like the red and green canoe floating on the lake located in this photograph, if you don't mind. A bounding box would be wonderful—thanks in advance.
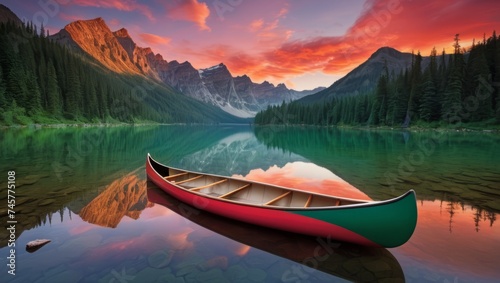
[146,154,417,248]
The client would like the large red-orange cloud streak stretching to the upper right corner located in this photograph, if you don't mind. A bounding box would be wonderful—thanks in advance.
[227,0,500,83]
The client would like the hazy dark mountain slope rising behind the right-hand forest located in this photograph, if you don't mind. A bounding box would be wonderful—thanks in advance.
[300,47,416,103]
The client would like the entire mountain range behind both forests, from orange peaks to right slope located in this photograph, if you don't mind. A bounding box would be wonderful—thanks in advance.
[0,5,429,121]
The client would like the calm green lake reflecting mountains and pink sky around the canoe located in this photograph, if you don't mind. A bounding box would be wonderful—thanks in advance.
[0,125,500,282]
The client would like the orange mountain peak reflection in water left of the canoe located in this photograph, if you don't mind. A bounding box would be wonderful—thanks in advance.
[79,172,153,228]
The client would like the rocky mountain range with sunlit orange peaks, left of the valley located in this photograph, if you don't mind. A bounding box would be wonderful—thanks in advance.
[51,18,324,118]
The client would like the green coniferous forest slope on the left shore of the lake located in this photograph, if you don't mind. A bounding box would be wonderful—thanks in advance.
[0,22,241,125]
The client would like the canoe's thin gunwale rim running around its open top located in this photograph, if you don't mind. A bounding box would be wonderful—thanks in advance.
[147,153,415,211]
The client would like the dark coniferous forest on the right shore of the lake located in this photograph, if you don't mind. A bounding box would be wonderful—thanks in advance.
[255,32,500,127]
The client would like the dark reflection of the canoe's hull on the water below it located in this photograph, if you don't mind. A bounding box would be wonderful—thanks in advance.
[147,181,404,282]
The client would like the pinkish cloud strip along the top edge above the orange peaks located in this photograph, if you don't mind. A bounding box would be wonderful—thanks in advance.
[70,0,155,21]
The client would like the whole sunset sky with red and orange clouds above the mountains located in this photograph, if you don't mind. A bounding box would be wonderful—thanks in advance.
[0,0,500,90]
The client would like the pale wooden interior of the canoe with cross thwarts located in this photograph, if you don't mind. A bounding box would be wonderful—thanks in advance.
[163,168,365,208]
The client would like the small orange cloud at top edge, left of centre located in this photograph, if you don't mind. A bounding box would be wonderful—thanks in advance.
[167,0,210,31]
